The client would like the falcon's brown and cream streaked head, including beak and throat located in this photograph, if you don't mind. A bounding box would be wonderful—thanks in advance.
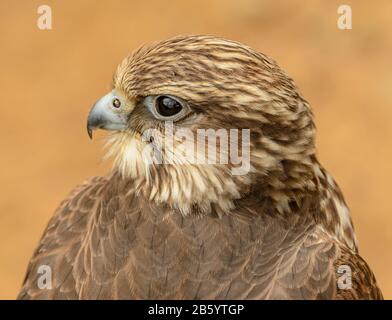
[87,36,315,214]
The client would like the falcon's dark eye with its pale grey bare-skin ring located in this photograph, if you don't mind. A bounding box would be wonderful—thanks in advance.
[144,94,191,121]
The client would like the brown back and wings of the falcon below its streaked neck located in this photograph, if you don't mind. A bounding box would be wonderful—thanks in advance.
[18,174,382,299]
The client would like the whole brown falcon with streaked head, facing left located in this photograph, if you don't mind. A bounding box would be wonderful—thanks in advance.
[18,36,382,299]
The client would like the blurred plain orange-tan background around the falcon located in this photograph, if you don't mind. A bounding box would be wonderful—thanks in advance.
[0,0,392,299]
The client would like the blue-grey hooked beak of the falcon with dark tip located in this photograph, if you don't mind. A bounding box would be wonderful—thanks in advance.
[87,90,128,139]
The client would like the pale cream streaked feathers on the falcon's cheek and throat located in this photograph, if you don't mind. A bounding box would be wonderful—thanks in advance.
[106,131,250,215]
